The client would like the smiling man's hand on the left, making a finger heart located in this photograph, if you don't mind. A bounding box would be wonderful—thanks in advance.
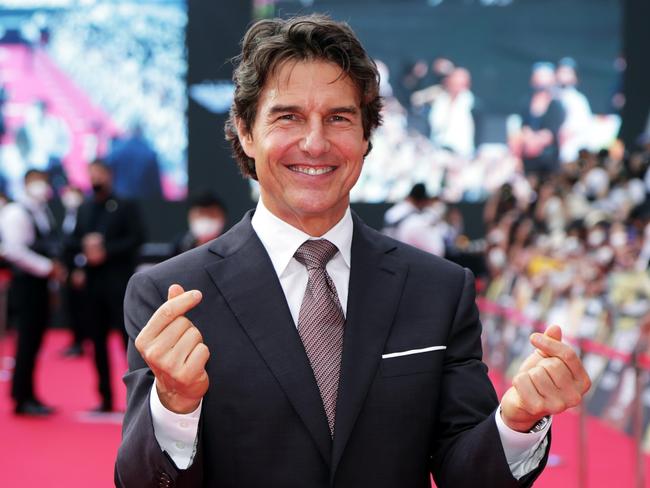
[135,284,210,413]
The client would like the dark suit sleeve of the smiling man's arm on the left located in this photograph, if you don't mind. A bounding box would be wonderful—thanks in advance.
[115,273,203,488]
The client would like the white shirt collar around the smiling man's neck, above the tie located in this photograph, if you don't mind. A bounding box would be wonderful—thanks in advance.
[251,198,354,276]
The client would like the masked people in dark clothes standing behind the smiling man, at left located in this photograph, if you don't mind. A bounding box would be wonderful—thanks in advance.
[0,156,226,416]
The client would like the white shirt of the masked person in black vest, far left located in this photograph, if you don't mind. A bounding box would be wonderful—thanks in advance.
[0,197,53,278]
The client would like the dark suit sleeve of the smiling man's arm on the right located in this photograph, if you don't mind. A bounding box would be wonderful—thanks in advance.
[430,270,550,488]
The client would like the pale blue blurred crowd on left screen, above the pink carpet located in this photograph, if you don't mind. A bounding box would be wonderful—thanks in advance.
[37,2,187,199]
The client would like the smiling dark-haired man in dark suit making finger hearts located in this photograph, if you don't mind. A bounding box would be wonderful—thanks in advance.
[115,16,589,488]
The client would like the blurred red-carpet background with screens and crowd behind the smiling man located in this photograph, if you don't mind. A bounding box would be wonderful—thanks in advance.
[0,0,650,488]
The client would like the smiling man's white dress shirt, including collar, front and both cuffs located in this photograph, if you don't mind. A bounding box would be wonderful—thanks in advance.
[149,199,550,478]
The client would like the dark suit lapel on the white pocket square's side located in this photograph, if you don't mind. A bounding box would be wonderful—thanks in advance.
[331,215,407,481]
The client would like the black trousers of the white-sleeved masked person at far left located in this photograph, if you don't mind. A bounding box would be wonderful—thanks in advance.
[10,273,50,403]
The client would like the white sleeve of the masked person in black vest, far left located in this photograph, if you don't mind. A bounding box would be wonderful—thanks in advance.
[0,203,52,278]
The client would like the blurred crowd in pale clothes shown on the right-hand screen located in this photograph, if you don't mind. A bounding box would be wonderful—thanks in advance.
[352,57,620,202]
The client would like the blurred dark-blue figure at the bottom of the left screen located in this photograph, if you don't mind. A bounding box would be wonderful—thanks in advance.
[106,124,162,199]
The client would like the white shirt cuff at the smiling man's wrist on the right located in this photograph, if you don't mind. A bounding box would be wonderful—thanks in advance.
[494,407,553,479]
